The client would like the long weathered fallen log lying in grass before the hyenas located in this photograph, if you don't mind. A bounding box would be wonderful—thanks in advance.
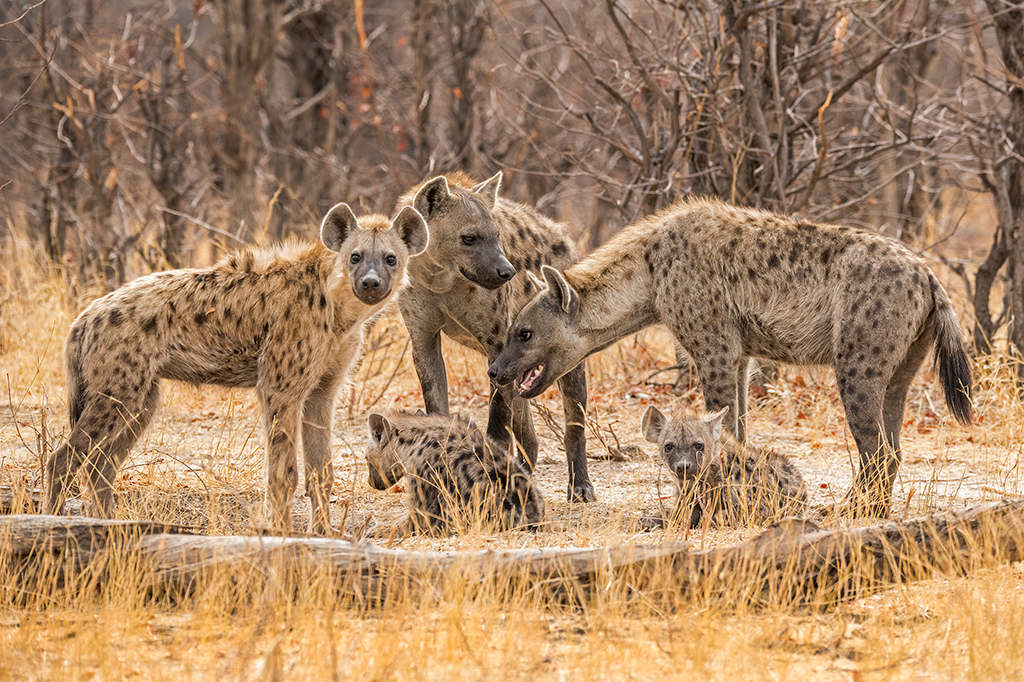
[0,500,1024,607]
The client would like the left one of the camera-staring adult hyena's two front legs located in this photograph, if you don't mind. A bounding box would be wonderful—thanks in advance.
[258,389,302,532]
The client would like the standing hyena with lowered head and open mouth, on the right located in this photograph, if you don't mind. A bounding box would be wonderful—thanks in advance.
[488,200,971,515]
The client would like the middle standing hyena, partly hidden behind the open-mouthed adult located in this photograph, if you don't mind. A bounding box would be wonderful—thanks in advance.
[398,173,594,502]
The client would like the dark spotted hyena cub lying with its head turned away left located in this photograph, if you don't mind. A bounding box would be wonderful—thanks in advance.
[367,414,544,535]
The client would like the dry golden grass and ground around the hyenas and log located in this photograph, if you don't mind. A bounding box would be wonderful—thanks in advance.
[0,240,1024,681]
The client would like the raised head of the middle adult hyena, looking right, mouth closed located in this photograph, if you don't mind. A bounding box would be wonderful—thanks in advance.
[413,172,515,289]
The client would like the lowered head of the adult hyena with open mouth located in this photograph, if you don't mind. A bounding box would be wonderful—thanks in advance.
[487,265,587,398]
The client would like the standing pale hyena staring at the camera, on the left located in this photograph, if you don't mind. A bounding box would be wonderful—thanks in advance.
[46,204,428,534]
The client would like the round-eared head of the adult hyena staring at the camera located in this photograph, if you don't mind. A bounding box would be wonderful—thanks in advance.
[321,204,430,305]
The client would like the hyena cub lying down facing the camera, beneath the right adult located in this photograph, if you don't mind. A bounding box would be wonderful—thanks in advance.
[641,406,807,528]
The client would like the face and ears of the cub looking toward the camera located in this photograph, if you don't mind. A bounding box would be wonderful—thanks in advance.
[640,406,729,483]
